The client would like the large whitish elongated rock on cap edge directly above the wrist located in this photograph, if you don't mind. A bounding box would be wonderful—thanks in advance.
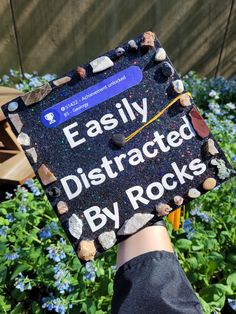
[117,213,154,235]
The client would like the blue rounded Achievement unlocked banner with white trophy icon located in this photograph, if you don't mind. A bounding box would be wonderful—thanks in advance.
[41,66,143,128]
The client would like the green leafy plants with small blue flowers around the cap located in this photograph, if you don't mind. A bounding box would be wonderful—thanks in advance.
[0,71,236,314]
